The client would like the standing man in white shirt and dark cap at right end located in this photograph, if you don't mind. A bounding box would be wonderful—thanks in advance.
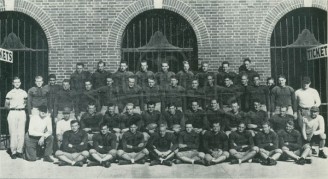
[295,76,321,128]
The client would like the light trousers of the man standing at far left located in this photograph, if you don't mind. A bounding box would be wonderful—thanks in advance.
[7,110,26,153]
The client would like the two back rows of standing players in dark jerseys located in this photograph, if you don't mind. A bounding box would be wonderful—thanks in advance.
[27,59,297,121]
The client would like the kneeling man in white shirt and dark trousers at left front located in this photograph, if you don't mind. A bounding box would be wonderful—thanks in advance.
[25,105,53,162]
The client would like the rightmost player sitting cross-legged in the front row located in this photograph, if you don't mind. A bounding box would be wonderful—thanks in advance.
[278,120,312,165]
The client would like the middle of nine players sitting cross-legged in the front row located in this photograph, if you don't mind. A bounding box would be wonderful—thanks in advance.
[176,123,205,164]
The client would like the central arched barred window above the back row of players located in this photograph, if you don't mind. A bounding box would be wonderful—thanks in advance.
[121,9,198,72]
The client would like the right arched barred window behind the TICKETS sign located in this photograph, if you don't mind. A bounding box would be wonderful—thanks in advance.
[271,8,327,102]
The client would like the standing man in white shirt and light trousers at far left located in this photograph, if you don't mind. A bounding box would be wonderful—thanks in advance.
[5,77,27,159]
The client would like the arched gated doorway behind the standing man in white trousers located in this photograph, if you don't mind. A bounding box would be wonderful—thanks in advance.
[0,11,48,141]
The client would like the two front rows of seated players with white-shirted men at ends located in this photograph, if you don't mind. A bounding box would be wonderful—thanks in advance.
[25,99,327,167]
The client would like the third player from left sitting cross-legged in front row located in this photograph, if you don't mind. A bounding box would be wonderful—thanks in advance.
[117,121,149,165]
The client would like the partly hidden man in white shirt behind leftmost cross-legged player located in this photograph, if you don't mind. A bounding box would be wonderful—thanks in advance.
[56,107,74,149]
